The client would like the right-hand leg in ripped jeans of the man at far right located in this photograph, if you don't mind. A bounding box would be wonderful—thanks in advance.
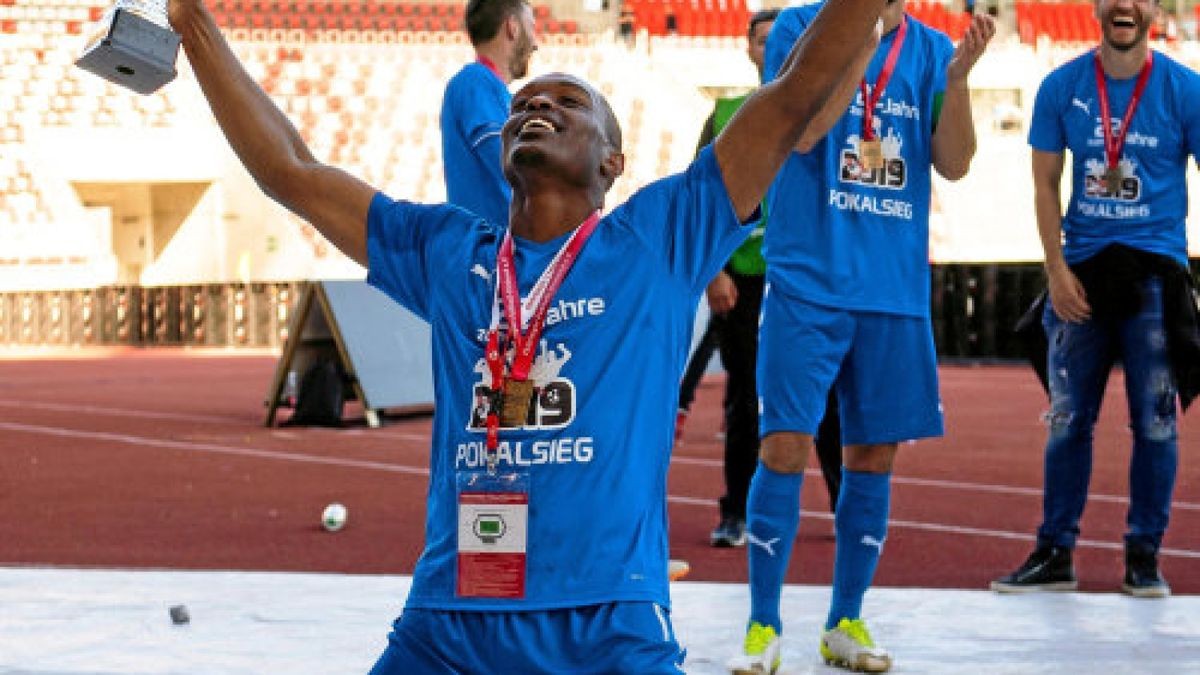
[1120,279,1178,597]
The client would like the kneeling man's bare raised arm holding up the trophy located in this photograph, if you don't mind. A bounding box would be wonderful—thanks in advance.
[169,0,376,265]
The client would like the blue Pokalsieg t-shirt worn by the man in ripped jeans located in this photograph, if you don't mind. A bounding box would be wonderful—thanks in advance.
[1030,52,1200,265]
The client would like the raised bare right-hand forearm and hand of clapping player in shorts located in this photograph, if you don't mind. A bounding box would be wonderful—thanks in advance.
[932,14,996,180]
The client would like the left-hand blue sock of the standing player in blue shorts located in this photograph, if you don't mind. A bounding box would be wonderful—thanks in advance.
[746,462,804,633]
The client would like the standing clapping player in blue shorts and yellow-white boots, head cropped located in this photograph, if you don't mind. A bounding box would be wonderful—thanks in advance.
[730,0,995,673]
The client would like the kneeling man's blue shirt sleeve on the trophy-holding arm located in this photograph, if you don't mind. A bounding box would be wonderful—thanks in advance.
[367,192,472,321]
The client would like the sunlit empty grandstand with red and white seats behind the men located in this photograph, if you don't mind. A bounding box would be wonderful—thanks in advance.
[0,0,1200,344]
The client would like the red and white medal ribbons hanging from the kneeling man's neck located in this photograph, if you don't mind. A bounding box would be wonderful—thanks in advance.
[485,211,600,450]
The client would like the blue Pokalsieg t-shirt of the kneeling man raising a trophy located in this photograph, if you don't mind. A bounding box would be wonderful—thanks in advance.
[367,149,752,610]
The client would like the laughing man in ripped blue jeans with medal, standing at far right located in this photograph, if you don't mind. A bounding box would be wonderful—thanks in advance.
[991,0,1200,597]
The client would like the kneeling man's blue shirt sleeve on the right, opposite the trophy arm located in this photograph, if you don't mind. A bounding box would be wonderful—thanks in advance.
[613,145,761,294]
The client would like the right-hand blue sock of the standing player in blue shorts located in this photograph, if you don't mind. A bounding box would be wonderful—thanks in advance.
[826,468,892,631]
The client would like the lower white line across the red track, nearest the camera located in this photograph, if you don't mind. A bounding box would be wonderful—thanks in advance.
[0,422,1200,560]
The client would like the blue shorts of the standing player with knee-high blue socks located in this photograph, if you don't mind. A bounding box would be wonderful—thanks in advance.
[758,288,942,446]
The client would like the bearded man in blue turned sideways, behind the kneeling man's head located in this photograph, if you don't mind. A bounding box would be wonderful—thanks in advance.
[440,0,538,225]
